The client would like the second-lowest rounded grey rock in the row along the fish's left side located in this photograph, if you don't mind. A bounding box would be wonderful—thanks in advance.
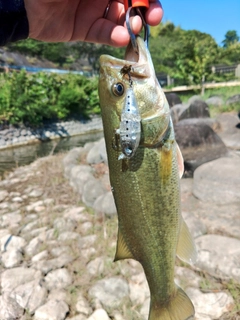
[82,178,106,207]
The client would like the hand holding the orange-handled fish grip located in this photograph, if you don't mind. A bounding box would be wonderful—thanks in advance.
[25,0,163,47]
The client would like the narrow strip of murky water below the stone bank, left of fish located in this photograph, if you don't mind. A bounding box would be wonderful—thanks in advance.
[0,132,103,175]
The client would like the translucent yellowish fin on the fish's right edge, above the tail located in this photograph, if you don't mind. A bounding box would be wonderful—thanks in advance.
[177,219,197,264]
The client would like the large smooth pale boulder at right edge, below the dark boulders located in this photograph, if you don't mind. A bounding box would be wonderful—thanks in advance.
[193,157,240,204]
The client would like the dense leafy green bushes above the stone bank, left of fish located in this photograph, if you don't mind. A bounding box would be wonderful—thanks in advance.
[0,70,100,126]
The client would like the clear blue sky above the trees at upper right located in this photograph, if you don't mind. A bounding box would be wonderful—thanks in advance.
[161,0,240,45]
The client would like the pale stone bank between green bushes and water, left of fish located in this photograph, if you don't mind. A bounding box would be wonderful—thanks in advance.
[0,116,103,150]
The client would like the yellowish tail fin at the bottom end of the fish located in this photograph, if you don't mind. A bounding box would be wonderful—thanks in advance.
[148,285,195,320]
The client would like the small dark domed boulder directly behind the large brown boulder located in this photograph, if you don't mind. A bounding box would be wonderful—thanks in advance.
[179,99,210,120]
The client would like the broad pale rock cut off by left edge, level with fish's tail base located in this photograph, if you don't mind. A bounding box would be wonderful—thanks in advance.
[1,267,41,292]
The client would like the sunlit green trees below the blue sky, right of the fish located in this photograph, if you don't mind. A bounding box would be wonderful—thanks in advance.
[150,22,240,85]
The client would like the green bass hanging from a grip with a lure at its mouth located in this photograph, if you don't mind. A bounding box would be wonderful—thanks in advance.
[98,36,197,320]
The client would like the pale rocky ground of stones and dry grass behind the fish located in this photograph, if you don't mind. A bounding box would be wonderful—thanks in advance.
[0,131,240,320]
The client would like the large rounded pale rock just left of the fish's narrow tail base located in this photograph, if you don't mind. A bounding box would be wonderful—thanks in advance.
[89,277,129,308]
